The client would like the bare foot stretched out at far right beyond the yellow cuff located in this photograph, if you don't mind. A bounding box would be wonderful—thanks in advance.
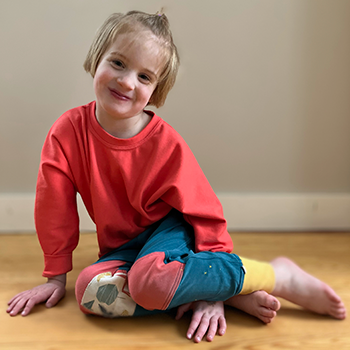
[271,257,346,320]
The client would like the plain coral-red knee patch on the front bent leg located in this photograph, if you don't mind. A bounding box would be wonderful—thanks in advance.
[128,252,184,310]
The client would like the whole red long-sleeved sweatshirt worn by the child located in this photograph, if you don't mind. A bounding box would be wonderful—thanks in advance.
[35,102,233,277]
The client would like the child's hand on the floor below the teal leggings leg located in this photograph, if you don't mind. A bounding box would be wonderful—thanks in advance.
[176,301,226,343]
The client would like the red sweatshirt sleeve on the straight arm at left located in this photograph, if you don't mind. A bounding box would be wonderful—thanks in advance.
[35,119,79,277]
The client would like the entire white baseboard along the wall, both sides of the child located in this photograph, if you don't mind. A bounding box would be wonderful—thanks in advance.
[0,193,350,233]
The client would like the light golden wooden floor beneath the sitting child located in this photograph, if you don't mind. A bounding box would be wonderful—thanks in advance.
[0,233,350,350]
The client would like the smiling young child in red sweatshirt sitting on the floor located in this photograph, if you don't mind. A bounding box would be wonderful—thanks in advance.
[7,11,346,341]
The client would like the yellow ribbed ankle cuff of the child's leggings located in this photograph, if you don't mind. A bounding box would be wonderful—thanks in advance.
[239,257,275,294]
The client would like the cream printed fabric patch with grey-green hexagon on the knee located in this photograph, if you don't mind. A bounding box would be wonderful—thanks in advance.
[81,270,136,318]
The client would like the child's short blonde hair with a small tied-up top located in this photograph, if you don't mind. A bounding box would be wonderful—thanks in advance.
[84,11,180,107]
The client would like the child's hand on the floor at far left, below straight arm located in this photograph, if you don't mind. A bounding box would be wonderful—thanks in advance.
[6,275,66,316]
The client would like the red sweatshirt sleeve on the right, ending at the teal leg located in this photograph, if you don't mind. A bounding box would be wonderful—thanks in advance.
[153,130,233,253]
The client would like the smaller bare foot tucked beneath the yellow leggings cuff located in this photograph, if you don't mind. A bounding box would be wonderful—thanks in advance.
[225,290,281,323]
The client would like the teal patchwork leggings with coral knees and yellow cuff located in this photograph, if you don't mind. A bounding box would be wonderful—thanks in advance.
[76,210,274,317]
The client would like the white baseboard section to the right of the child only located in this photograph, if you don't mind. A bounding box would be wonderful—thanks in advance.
[218,193,350,231]
